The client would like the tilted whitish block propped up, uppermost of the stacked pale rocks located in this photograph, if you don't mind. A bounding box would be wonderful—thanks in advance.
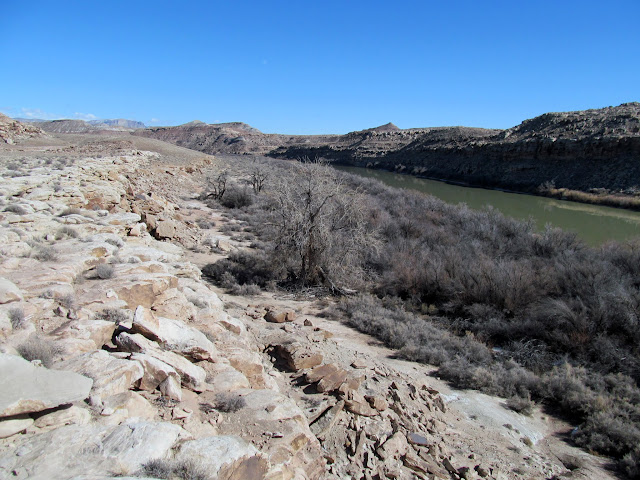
[132,305,218,361]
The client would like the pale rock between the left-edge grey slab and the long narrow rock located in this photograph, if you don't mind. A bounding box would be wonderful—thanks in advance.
[55,350,144,397]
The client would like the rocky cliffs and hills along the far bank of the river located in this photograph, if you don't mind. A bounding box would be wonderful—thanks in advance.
[134,102,640,191]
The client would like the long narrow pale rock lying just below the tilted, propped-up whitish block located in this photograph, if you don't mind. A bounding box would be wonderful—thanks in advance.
[116,332,207,392]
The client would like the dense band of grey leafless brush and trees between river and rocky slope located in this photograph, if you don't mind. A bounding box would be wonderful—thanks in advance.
[203,157,640,477]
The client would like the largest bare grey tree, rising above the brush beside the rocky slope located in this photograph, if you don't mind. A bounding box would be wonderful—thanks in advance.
[273,161,377,293]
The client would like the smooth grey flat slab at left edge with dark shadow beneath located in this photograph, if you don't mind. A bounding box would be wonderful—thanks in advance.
[0,353,93,417]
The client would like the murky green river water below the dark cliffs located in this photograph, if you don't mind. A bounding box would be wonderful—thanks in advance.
[337,167,640,246]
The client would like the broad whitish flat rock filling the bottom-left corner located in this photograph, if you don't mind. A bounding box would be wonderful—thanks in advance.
[0,422,188,480]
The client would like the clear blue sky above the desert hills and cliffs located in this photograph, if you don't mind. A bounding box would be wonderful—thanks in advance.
[0,0,640,134]
